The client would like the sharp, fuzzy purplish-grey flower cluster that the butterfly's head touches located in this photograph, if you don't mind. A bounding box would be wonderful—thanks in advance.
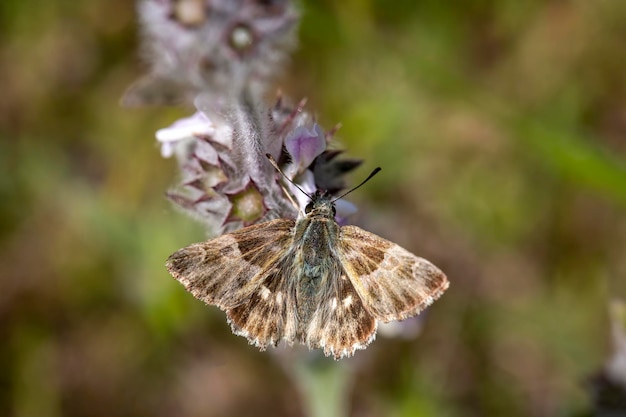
[157,94,360,233]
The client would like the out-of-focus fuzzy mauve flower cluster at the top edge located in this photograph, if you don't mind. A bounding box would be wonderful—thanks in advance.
[123,0,298,106]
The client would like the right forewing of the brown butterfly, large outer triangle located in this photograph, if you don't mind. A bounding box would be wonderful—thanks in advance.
[338,226,449,322]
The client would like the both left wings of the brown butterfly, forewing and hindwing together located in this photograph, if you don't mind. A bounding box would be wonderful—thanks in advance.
[166,219,295,349]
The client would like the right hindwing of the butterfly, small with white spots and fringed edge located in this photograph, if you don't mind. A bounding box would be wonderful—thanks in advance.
[305,259,376,359]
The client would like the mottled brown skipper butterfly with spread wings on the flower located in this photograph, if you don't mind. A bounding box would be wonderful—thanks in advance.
[166,156,449,359]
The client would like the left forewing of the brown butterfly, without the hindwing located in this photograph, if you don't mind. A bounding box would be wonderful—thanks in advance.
[166,219,295,310]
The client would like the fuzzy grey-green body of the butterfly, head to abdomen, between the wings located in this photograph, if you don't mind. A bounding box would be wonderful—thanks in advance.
[294,192,339,335]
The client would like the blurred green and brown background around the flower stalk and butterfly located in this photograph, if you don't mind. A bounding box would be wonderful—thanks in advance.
[0,0,626,417]
